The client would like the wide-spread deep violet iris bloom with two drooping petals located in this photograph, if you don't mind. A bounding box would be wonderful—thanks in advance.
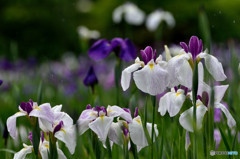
[88,38,137,62]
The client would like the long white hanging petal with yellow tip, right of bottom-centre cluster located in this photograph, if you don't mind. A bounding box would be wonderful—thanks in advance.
[128,116,148,150]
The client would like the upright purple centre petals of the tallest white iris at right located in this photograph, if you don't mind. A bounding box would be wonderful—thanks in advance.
[180,36,203,60]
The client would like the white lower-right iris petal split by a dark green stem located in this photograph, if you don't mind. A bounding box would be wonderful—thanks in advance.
[179,105,207,132]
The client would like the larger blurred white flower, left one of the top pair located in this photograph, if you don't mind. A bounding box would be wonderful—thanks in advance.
[112,2,145,25]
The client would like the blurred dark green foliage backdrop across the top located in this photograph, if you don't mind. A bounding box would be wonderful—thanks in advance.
[0,0,240,60]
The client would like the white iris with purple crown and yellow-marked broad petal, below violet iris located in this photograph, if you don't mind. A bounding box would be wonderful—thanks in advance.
[121,46,168,95]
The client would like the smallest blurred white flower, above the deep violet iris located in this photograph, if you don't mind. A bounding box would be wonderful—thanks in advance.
[77,26,100,39]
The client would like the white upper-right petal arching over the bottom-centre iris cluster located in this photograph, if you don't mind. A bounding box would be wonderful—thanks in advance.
[107,106,132,122]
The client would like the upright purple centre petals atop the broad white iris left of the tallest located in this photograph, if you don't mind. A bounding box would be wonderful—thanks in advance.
[140,46,157,65]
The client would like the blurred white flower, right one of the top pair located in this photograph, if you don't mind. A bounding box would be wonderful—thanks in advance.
[146,9,175,31]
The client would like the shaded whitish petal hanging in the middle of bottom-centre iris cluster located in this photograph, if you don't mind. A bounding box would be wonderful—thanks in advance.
[108,122,123,146]
